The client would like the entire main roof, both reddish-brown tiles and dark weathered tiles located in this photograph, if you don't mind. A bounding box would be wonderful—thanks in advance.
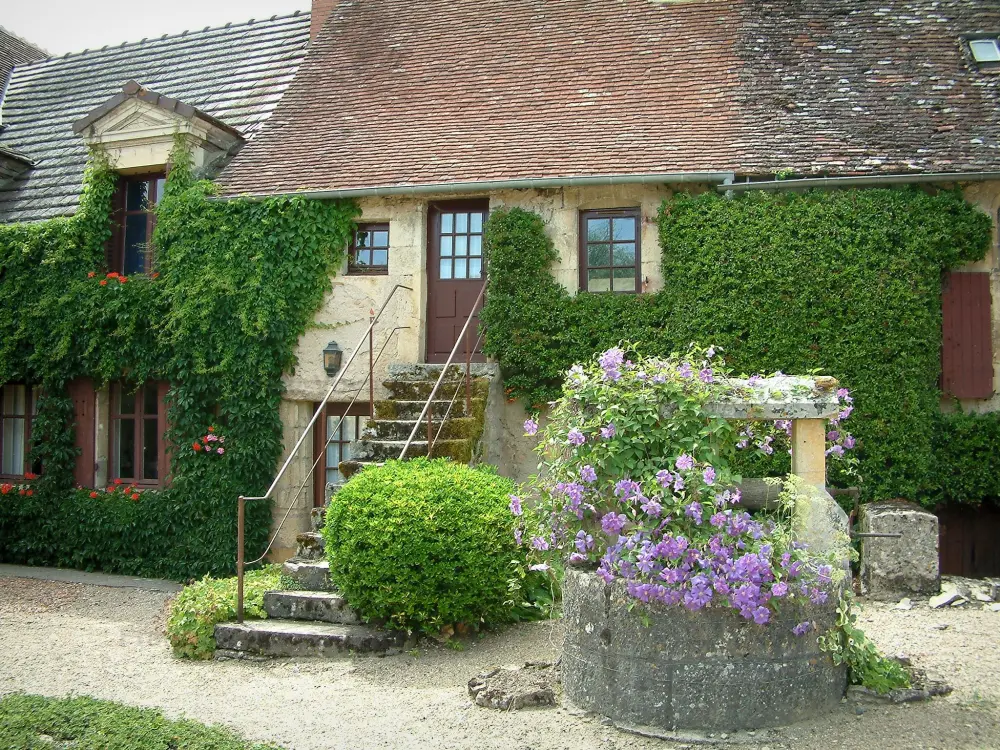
[220,0,1000,194]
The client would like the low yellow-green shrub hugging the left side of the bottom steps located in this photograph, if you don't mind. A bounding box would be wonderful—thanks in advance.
[167,565,281,659]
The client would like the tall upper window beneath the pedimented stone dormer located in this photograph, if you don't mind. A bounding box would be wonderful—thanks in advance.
[108,173,166,276]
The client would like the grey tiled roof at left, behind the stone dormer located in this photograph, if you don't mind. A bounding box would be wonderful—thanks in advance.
[0,13,309,221]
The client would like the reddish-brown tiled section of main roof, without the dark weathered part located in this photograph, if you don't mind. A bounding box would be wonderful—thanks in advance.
[221,0,752,193]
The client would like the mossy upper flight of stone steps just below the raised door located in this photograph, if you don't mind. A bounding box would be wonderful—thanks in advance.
[340,363,495,478]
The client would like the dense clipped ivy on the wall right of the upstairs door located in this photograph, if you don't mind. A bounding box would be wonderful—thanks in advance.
[483,189,1000,505]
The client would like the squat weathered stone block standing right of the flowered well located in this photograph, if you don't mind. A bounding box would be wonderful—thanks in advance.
[858,500,941,600]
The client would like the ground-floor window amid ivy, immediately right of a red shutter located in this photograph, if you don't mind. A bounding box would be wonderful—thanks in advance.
[111,383,166,486]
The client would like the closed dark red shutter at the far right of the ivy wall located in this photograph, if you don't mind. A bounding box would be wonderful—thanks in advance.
[941,272,993,398]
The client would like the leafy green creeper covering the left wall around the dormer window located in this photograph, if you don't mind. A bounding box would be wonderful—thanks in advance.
[0,147,357,579]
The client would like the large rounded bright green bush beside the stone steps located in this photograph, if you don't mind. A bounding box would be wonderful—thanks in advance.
[324,458,523,632]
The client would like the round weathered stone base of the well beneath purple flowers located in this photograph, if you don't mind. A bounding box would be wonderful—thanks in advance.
[562,568,847,730]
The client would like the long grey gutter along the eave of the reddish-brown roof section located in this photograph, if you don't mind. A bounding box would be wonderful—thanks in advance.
[209,172,735,201]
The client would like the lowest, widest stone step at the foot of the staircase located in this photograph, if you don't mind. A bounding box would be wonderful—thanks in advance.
[215,620,406,659]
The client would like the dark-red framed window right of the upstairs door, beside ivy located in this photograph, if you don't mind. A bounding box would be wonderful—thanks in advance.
[580,208,641,294]
